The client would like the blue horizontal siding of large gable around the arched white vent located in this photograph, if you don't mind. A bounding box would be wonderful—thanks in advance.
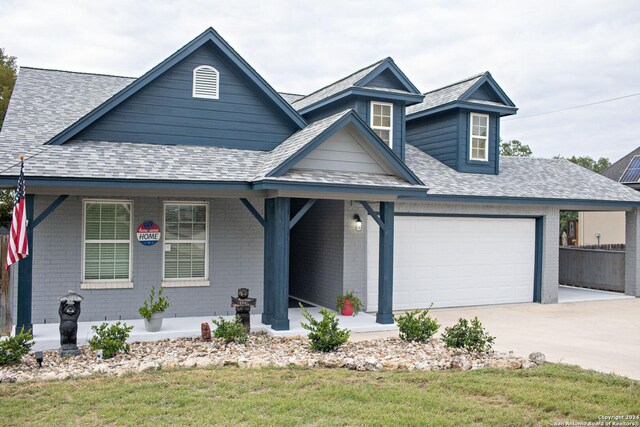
[76,46,295,150]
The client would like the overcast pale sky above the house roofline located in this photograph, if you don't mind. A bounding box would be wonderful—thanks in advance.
[0,0,640,160]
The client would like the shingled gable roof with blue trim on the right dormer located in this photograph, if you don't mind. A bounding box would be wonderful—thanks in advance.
[406,71,516,119]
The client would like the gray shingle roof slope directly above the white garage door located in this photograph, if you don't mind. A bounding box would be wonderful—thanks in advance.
[406,144,640,202]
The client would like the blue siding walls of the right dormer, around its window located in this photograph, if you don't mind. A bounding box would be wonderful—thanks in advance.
[406,110,500,175]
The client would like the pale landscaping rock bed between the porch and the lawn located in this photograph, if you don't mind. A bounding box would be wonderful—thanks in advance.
[0,334,544,383]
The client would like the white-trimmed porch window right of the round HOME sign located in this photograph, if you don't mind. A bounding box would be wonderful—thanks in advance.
[163,202,209,281]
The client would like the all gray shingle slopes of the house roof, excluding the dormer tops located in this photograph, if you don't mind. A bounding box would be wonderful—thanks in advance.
[0,67,640,206]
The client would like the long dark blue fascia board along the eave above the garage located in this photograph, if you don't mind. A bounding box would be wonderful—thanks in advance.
[420,194,640,207]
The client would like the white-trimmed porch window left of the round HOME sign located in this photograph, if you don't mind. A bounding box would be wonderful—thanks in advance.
[82,200,131,283]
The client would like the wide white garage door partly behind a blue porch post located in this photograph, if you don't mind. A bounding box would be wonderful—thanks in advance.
[367,216,535,311]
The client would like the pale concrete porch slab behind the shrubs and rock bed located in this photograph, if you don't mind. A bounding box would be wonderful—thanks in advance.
[33,307,398,351]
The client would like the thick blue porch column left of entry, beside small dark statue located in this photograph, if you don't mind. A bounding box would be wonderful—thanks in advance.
[262,197,291,331]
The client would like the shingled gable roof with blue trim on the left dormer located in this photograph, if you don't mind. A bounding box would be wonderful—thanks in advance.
[291,58,421,112]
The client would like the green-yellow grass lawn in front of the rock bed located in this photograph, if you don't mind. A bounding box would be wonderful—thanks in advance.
[0,364,640,426]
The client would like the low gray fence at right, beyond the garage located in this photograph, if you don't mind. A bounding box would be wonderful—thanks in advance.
[559,247,625,292]
